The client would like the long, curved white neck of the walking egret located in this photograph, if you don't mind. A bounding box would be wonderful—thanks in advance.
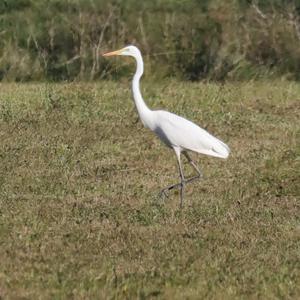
[132,53,152,128]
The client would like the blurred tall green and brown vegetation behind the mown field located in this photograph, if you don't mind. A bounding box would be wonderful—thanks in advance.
[0,0,300,81]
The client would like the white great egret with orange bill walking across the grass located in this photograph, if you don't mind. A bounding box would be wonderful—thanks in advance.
[103,45,230,206]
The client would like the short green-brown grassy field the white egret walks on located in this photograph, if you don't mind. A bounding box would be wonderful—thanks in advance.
[0,80,300,299]
